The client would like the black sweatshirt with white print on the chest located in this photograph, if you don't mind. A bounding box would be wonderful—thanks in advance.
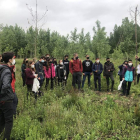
[82,60,93,73]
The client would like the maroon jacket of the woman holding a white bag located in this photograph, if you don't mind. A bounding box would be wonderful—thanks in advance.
[25,68,35,85]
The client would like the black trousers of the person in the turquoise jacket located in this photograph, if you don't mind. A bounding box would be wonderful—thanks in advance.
[122,80,132,96]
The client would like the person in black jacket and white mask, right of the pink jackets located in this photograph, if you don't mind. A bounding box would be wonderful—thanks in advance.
[56,60,67,87]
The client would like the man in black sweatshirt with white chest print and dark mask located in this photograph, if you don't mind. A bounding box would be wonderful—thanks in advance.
[82,55,93,88]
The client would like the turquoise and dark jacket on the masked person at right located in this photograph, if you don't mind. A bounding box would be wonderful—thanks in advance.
[122,66,135,82]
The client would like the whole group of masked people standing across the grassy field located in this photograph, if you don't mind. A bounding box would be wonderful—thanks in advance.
[0,52,140,140]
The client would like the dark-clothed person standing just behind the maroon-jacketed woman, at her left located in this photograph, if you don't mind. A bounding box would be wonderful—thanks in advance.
[21,58,28,87]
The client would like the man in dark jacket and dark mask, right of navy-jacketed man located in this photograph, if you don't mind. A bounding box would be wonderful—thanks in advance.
[104,58,115,91]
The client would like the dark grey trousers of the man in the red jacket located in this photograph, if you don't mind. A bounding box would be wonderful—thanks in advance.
[72,72,82,89]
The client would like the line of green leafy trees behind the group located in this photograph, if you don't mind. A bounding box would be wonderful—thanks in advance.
[0,17,140,59]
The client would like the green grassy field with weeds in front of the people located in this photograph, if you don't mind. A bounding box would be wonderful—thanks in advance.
[1,60,140,140]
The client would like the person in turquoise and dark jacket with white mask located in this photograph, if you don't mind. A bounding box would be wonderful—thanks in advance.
[122,60,135,96]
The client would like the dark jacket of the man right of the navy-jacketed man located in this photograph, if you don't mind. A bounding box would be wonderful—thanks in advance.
[104,62,115,76]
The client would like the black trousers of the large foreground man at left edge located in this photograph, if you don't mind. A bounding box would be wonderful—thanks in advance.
[0,101,13,140]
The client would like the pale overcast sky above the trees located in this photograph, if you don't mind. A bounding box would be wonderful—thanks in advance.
[0,0,140,35]
